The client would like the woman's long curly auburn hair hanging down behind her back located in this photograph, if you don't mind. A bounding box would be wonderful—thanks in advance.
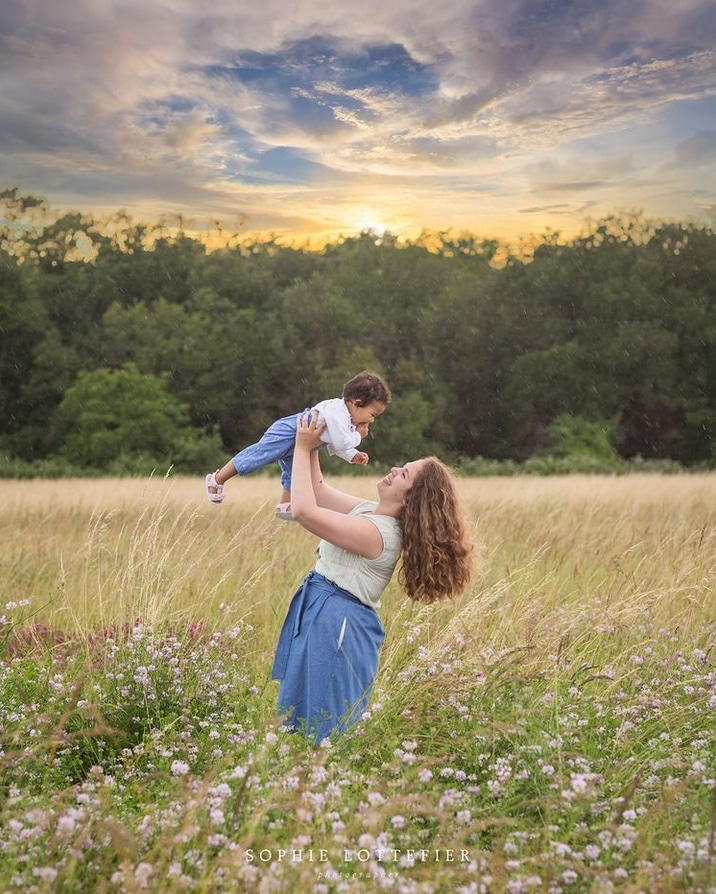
[399,456,472,604]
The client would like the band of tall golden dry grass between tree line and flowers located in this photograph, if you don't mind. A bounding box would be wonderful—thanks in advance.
[0,474,716,662]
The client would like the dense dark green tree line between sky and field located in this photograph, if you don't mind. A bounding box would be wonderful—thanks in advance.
[0,189,716,472]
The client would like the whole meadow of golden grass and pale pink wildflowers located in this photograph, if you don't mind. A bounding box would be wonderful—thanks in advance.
[0,474,716,894]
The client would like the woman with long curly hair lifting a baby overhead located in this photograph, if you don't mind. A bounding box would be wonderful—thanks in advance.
[272,413,471,743]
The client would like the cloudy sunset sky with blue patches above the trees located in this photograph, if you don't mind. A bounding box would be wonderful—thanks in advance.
[0,0,716,245]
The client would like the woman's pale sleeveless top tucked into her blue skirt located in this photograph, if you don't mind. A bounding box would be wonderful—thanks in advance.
[316,500,403,609]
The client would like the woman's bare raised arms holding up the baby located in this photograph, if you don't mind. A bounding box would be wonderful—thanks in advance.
[291,415,383,559]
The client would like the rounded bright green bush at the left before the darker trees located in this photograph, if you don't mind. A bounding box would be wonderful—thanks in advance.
[57,362,217,474]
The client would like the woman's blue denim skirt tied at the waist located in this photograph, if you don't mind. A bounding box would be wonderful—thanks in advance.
[271,571,385,744]
